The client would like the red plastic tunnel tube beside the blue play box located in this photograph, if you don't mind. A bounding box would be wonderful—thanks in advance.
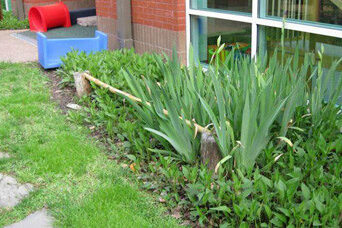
[29,2,71,32]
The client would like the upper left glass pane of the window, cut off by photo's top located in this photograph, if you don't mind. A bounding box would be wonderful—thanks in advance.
[191,0,252,13]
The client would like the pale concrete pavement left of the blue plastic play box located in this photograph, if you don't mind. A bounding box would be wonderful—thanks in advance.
[0,30,38,63]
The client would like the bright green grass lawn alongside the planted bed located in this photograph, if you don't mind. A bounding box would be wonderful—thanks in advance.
[0,62,177,227]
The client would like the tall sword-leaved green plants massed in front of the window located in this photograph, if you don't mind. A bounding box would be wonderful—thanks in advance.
[125,40,342,171]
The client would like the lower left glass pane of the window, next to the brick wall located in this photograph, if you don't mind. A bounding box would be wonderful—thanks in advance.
[191,16,251,63]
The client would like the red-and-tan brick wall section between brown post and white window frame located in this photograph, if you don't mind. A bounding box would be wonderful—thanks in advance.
[132,0,186,62]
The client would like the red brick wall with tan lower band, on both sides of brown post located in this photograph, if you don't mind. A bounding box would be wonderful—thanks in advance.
[96,0,186,63]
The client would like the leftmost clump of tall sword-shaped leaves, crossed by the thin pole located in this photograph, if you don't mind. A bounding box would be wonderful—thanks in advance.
[123,49,213,163]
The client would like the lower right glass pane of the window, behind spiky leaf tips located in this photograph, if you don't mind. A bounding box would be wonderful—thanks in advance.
[258,26,342,104]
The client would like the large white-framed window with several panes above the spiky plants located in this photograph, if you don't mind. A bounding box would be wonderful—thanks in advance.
[186,0,342,64]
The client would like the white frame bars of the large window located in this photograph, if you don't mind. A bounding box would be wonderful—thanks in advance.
[185,0,342,64]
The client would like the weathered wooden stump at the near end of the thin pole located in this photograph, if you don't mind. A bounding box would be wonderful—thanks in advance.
[201,132,221,170]
